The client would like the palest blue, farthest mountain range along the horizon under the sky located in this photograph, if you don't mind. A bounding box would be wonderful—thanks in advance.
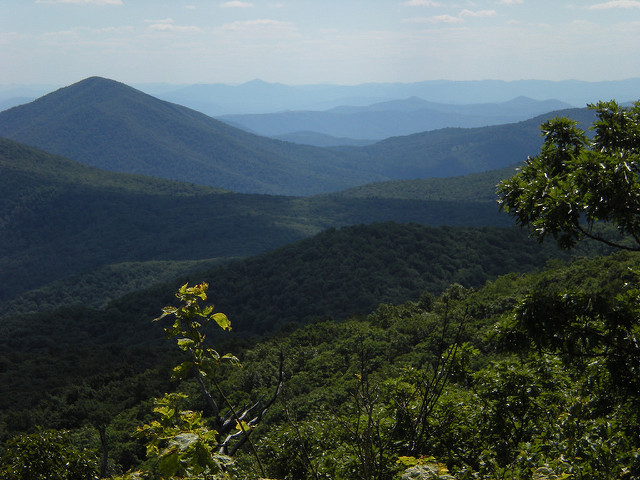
[149,78,640,117]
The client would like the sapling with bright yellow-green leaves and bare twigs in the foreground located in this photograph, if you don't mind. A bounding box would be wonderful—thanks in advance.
[129,283,282,478]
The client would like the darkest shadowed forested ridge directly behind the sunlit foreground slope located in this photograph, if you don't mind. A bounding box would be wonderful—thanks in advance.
[0,219,604,426]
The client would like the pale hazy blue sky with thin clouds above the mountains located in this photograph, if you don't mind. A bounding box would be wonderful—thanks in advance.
[0,0,640,85]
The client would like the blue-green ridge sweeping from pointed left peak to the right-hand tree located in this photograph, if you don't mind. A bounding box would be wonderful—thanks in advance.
[0,77,592,195]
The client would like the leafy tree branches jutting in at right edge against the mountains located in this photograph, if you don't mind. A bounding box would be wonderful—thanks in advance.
[498,101,640,250]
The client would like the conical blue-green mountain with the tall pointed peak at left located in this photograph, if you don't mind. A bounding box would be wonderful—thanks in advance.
[0,77,383,195]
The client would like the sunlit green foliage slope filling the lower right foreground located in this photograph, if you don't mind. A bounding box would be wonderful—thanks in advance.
[6,249,640,480]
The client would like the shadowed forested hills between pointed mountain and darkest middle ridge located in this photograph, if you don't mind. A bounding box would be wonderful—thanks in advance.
[0,139,508,311]
